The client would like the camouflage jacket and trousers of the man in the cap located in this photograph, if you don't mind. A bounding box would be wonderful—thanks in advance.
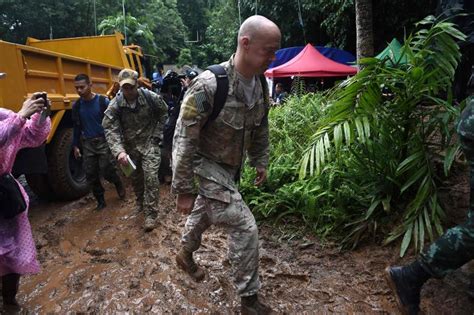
[102,89,168,219]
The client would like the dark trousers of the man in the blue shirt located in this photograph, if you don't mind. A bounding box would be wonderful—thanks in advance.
[83,137,121,197]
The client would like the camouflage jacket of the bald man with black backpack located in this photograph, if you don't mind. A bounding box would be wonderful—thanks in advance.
[172,57,269,201]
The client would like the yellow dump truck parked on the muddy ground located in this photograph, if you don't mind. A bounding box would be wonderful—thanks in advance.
[0,33,144,200]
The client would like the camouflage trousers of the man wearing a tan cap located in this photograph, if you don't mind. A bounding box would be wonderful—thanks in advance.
[127,146,161,219]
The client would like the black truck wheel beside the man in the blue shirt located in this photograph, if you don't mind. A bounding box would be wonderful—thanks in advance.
[48,128,89,200]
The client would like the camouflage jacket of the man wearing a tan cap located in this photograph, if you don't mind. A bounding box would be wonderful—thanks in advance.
[102,89,168,157]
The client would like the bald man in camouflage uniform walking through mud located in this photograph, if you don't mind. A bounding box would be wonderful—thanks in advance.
[171,15,281,314]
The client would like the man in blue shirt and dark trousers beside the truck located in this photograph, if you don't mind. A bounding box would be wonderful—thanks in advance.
[72,74,125,210]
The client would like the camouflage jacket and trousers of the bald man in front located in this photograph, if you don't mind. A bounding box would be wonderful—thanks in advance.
[172,57,269,296]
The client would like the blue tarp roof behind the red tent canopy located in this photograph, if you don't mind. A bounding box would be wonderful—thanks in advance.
[268,46,355,69]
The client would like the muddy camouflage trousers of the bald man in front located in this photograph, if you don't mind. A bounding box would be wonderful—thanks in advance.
[181,192,260,296]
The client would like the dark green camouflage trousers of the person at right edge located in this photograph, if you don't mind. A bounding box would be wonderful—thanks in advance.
[421,137,474,278]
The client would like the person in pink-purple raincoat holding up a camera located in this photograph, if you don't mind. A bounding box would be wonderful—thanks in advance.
[0,93,51,312]
